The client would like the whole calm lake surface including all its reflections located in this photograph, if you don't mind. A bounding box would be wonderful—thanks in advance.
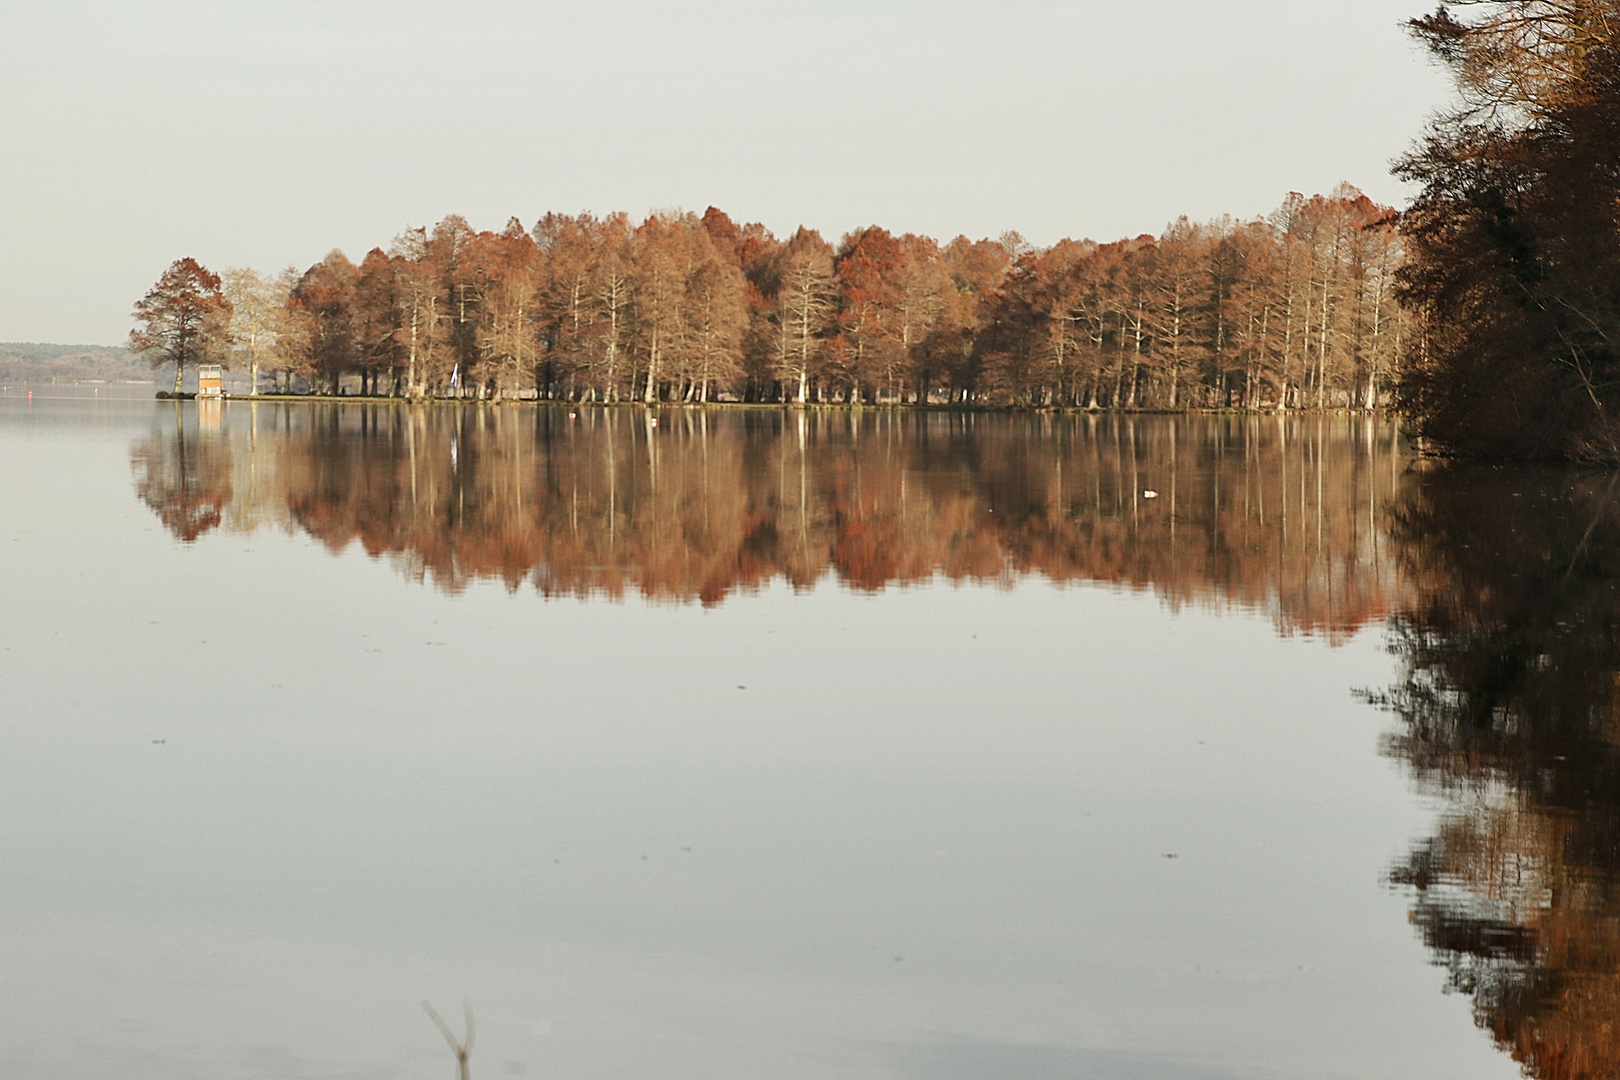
[0,389,1594,1080]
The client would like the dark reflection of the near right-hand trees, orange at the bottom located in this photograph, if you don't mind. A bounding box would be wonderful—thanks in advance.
[1379,468,1620,1080]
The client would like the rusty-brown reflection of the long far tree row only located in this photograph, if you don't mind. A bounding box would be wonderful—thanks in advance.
[133,403,1406,636]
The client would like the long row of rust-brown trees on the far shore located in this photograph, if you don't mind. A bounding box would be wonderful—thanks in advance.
[131,185,1414,410]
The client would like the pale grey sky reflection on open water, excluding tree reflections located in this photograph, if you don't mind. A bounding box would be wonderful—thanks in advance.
[0,396,1513,1080]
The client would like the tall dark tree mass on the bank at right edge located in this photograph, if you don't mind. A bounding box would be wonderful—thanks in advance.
[1396,0,1620,463]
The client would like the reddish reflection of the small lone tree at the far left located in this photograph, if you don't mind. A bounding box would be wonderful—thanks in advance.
[130,402,232,542]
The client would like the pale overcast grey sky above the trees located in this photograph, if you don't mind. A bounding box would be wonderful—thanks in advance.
[0,0,1447,343]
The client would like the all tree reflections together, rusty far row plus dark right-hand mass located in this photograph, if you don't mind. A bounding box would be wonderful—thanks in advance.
[131,403,1620,1080]
